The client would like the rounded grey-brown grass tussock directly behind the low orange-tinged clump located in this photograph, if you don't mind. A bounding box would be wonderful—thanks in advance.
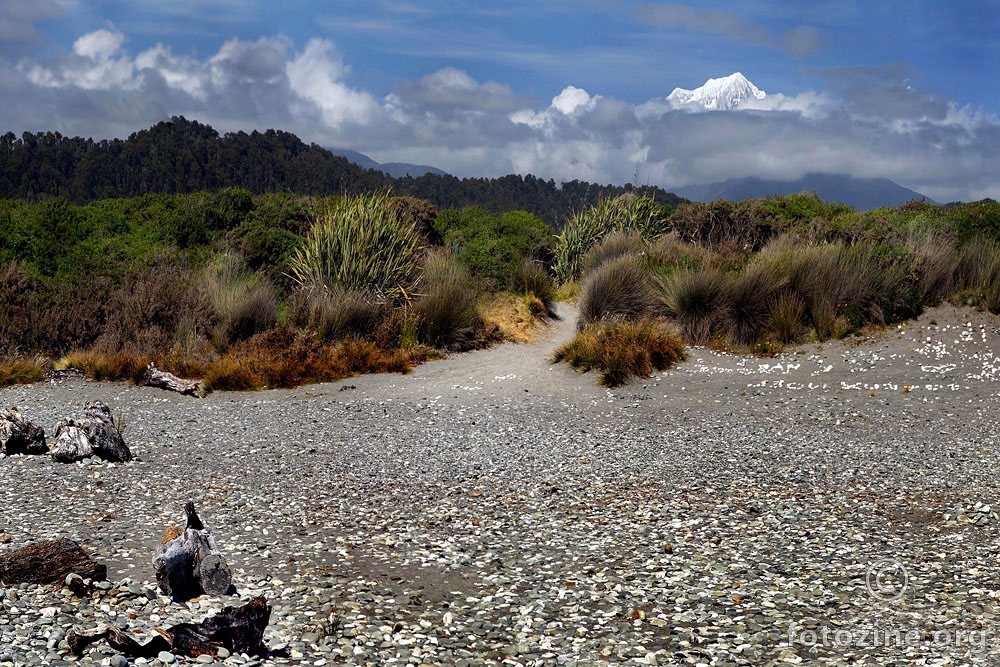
[578,256,659,329]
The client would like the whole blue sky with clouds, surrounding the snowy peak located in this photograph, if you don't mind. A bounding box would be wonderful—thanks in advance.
[0,0,1000,202]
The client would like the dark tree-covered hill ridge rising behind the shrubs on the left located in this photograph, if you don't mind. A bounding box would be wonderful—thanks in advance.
[0,117,683,225]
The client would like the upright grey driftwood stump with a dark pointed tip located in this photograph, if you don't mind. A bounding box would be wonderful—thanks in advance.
[153,502,233,600]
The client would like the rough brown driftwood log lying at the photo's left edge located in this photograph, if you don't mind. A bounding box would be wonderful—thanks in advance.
[0,539,108,586]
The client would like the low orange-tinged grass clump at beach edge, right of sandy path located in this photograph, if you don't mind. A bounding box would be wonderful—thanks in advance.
[553,319,685,387]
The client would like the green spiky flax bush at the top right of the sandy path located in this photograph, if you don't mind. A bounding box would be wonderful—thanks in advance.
[553,195,668,282]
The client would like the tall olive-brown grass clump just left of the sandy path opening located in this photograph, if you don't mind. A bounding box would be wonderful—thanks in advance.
[413,253,481,350]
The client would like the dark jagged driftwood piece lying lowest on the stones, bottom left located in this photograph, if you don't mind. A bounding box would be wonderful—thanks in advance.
[66,597,271,658]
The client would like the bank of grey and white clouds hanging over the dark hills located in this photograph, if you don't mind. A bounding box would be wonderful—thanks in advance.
[0,29,1000,201]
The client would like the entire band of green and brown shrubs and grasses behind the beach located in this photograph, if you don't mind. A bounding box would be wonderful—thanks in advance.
[0,183,1000,389]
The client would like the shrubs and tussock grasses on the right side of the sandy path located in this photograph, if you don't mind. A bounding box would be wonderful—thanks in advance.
[556,190,1000,382]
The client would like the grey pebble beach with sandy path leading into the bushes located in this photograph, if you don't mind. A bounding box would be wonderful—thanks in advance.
[0,307,1000,667]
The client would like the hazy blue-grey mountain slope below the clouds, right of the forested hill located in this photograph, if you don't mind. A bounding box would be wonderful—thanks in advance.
[676,173,935,210]
